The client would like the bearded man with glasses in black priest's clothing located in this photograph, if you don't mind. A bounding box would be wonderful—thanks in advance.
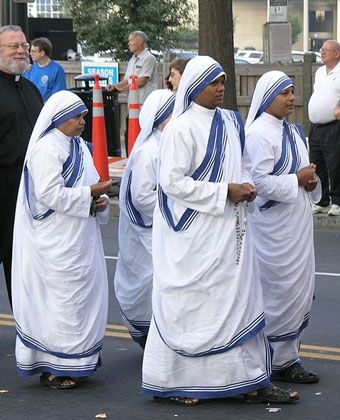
[0,25,43,302]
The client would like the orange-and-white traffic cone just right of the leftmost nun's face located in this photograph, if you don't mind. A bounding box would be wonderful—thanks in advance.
[92,74,110,181]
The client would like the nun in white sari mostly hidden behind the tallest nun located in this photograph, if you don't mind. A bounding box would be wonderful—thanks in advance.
[114,89,175,348]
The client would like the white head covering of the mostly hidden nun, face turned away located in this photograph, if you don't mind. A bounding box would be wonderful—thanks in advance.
[134,89,175,148]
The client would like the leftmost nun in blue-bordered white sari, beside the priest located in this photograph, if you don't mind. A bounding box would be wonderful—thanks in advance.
[12,91,111,389]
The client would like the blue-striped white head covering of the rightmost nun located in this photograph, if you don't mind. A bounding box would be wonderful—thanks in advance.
[245,70,294,129]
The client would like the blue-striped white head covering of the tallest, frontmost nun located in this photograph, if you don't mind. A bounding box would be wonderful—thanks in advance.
[172,55,225,118]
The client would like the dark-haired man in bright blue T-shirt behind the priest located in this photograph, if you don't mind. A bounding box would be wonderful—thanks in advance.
[24,38,67,102]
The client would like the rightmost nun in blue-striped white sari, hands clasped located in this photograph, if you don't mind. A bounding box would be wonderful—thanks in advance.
[244,71,321,383]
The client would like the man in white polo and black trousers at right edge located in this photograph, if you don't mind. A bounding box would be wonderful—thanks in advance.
[308,39,340,216]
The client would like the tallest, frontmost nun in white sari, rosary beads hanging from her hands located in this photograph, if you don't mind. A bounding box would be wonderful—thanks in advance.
[142,56,297,405]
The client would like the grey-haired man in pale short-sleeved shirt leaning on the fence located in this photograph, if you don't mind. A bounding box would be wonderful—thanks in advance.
[107,31,157,105]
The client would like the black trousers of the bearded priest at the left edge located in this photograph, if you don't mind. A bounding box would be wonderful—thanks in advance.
[0,165,22,306]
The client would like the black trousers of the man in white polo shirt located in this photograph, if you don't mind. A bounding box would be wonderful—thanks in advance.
[309,120,340,206]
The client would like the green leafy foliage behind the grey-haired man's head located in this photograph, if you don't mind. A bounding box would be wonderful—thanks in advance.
[63,0,192,60]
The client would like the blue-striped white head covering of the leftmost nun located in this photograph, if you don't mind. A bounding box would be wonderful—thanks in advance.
[26,90,87,160]
